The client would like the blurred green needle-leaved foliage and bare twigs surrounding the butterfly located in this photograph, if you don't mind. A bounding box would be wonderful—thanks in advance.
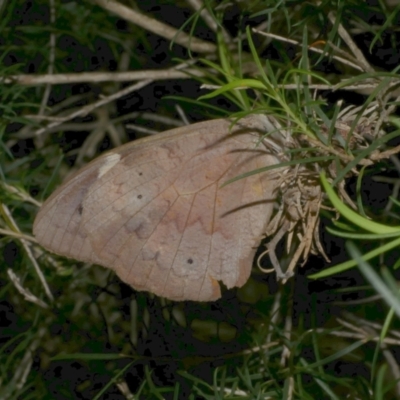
[0,0,400,399]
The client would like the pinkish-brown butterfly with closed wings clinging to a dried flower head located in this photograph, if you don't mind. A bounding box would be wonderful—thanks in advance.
[33,115,279,301]
